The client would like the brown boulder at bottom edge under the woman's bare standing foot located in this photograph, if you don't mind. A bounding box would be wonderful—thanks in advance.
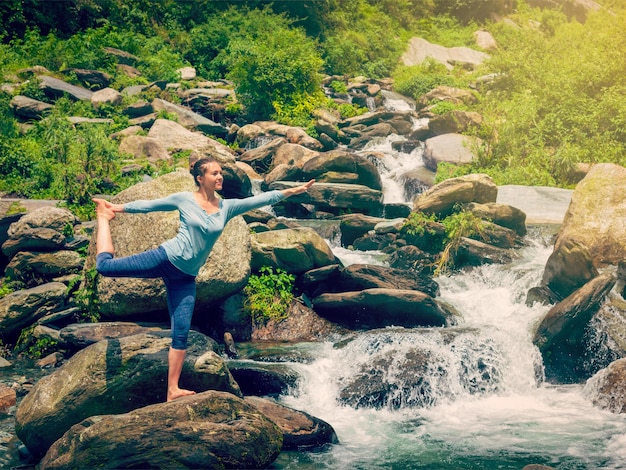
[40,391,283,469]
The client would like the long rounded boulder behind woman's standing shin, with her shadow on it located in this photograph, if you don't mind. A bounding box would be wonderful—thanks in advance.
[15,330,241,455]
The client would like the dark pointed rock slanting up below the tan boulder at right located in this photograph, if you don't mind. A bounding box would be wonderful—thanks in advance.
[533,273,615,383]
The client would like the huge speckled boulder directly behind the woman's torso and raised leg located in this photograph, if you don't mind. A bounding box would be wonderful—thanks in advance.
[85,170,251,320]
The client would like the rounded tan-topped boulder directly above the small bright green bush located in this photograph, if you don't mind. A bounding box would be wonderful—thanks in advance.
[250,228,336,274]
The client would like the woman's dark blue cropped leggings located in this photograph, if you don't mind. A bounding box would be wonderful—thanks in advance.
[96,247,196,349]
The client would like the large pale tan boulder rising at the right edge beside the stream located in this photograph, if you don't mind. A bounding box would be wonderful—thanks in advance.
[542,163,626,297]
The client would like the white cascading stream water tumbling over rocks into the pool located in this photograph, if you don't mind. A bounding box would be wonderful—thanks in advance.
[271,124,626,470]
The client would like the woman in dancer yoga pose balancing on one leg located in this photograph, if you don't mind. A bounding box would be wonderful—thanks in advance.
[93,158,315,401]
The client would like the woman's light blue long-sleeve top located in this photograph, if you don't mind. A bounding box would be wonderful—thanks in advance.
[124,190,285,276]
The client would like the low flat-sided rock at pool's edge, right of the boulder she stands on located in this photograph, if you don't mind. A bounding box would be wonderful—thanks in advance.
[245,397,339,451]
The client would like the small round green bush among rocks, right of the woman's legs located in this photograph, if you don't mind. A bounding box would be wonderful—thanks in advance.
[244,266,295,325]
